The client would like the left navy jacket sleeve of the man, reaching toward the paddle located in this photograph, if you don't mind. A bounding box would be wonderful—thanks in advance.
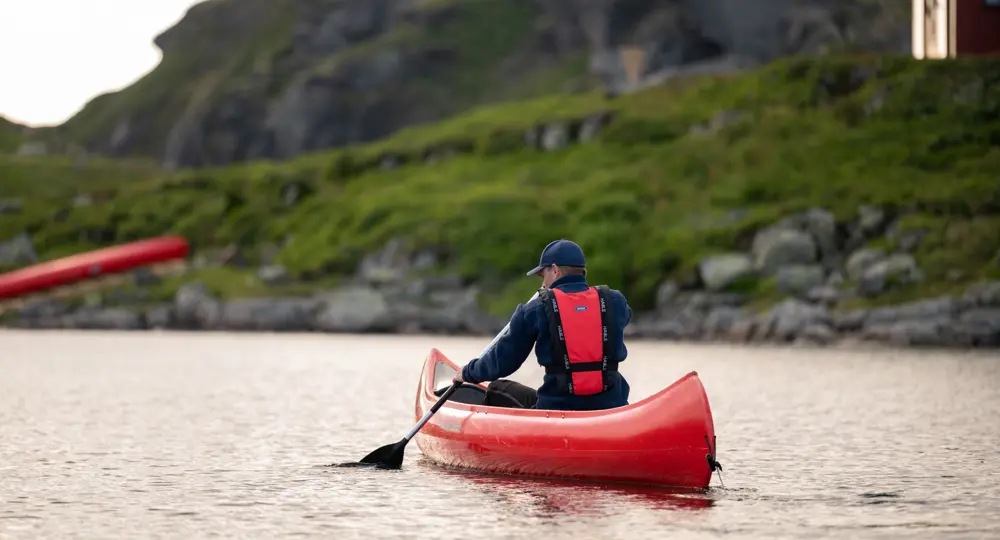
[462,304,538,383]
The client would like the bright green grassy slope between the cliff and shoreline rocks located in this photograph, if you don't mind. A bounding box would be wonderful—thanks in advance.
[0,53,1000,312]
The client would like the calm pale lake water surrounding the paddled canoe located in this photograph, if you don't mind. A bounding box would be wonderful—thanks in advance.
[0,331,1000,539]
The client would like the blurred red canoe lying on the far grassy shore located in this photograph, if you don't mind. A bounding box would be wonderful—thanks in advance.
[0,236,189,298]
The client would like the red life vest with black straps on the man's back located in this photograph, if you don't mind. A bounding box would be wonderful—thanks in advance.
[538,285,618,396]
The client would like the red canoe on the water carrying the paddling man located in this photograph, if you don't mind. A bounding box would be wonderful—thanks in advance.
[415,349,716,488]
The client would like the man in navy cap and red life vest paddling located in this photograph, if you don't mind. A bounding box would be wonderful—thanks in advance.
[455,239,632,411]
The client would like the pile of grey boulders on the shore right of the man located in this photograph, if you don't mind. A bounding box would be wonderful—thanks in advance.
[629,206,1000,347]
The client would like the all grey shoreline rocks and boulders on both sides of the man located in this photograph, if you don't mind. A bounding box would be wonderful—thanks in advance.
[0,202,1000,348]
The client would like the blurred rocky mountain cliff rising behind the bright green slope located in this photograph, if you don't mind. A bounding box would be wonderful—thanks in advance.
[58,0,910,167]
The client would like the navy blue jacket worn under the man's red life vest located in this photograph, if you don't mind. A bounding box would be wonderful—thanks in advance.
[462,276,632,411]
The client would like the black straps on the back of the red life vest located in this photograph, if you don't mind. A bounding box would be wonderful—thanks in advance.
[538,285,618,394]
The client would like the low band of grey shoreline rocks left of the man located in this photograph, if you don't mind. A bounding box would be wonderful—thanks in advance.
[6,279,504,334]
